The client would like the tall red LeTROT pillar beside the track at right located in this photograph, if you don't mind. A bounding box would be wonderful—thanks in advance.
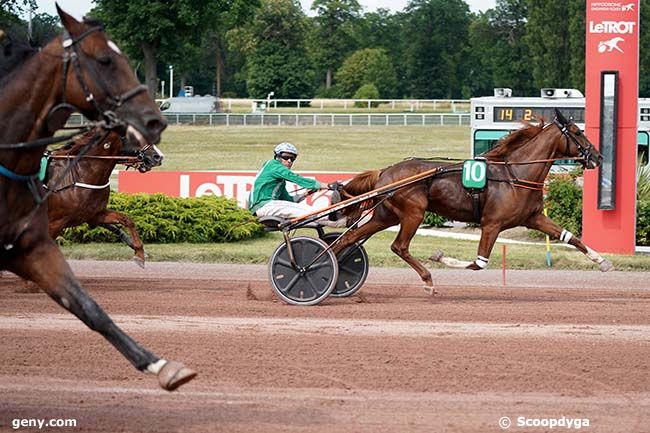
[582,0,639,254]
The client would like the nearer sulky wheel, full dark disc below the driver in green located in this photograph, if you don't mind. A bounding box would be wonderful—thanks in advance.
[269,236,339,305]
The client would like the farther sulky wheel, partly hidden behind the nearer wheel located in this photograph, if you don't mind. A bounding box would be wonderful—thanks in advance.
[321,233,368,298]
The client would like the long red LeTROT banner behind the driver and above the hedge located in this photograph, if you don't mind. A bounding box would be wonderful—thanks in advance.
[118,171,357,207]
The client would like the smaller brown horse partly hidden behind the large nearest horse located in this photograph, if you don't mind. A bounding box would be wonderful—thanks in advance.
[44,129,164,267]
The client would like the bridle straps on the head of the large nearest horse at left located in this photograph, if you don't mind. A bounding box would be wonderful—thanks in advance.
[49,26,148,129]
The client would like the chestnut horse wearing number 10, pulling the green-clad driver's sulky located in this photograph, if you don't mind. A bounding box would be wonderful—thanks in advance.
[334,110,612,293]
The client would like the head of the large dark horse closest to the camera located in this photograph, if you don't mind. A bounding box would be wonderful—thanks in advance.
[51,4,167,144]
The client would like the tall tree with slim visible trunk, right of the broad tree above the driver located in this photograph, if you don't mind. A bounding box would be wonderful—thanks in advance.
[311,0,361,89]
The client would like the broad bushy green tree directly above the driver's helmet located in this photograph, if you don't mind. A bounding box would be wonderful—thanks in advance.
[228,0,314,99]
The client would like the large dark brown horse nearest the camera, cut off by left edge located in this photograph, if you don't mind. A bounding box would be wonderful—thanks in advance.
[0,5,196,390]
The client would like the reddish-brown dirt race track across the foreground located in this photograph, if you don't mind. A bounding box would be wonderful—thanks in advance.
[0,261,650,433]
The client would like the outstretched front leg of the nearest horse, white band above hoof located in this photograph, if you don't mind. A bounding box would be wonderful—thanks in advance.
[8,236,196,391]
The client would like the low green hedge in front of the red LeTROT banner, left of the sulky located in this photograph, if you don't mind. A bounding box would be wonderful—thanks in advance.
[62,192,264,243]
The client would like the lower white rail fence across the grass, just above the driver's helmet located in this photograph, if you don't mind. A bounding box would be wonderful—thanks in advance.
[68,113,470,127]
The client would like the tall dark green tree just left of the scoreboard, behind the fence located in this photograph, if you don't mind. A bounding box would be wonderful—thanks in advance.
[405,0,469,98]
